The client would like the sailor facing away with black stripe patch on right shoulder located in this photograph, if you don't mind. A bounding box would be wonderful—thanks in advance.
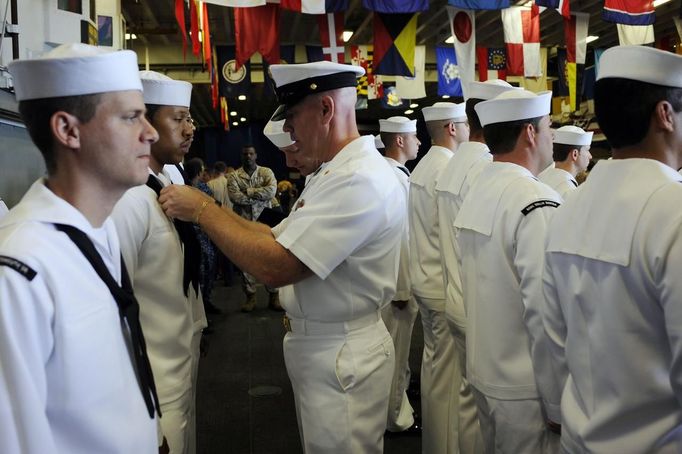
[455,90,561,454]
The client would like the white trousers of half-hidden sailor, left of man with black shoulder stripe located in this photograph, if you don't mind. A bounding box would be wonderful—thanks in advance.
[445,306,484,454]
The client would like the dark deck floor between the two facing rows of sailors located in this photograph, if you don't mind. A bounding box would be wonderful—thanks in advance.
[197,279,423,454]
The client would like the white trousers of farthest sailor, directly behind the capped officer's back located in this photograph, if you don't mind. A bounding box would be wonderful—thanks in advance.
[381,298,419,432]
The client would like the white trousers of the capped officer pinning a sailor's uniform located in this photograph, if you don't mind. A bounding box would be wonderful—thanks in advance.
[284,315,394,454]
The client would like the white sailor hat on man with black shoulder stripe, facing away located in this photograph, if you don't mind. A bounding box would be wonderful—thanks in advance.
[474,90,552,126]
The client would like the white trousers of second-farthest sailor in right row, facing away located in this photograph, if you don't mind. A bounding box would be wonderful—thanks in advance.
[415,296,458,454]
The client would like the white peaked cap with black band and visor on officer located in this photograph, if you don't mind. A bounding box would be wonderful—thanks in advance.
[270,61,365,120]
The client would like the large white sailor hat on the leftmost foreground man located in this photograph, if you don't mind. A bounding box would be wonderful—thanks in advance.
[9,43,142,101]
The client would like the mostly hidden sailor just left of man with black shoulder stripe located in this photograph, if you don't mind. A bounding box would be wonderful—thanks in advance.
[436,79,518,453]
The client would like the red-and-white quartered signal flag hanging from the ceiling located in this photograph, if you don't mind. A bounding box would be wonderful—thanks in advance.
[502,4,542,77]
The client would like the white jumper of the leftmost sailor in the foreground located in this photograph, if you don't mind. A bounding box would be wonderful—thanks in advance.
[0,180,158,454]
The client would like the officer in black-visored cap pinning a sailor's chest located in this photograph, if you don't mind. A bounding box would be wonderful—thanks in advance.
[159,62,406,454]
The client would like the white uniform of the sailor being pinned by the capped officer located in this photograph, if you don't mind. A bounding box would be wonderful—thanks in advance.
[111,170,205,453]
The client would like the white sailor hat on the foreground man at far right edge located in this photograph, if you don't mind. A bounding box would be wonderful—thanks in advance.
[597,46,682,87]
